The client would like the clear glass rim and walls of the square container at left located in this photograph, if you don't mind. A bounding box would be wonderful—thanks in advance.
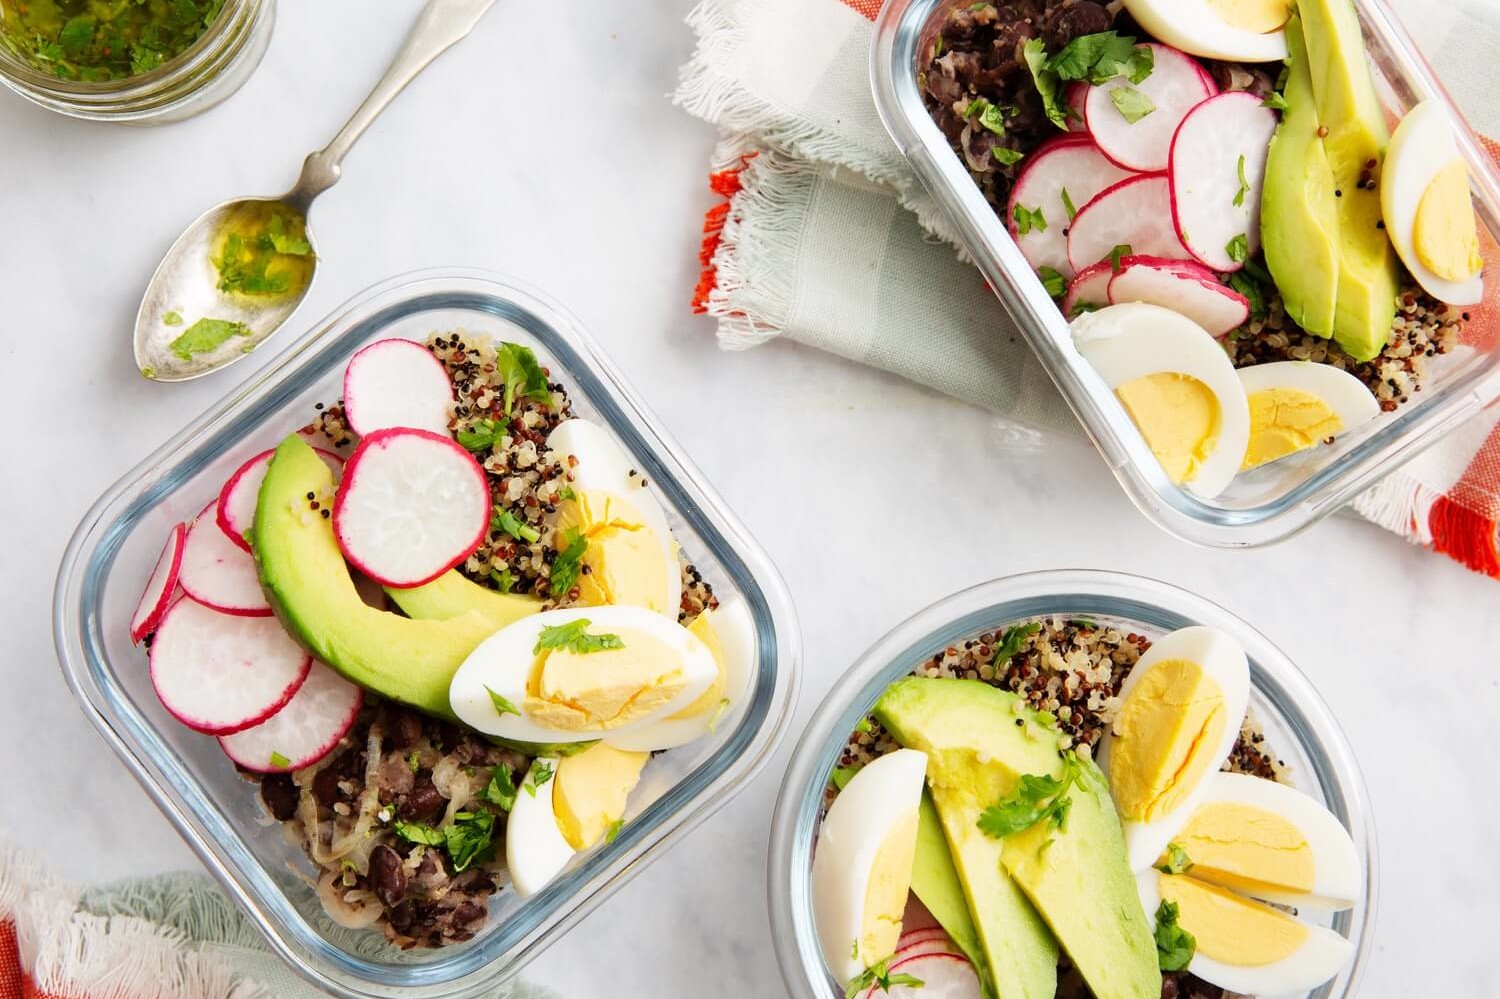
[53,270,800,998]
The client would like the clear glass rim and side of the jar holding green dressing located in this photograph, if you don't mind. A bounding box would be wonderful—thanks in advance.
[0,0,276,125]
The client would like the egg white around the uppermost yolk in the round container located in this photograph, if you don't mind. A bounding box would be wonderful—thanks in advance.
[1097,626,1250,870]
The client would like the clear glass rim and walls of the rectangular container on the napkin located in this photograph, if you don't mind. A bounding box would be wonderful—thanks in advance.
[870,0,1500,548]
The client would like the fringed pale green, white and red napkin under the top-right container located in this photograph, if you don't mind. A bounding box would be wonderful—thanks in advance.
[675,0,1500,578]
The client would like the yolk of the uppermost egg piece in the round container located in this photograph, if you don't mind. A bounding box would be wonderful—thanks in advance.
[1110,659,1227,816]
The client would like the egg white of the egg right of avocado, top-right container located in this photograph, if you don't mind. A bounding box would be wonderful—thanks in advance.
[1380,99,1485,305]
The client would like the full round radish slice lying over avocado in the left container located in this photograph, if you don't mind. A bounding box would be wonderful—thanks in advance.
[333,429,491,587]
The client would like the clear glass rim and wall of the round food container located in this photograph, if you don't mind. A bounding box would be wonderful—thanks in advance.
[768,570,1379,999]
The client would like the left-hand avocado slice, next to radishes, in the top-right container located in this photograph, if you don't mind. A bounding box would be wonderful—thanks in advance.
[1260,15,1340,336]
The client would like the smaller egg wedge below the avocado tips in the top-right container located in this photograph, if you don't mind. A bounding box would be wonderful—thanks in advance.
[1239,362,1380,470]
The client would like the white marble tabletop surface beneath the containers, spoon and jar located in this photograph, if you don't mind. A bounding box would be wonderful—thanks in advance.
[0,0,1500,999]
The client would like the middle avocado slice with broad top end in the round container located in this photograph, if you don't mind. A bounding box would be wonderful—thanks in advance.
[875,677,1062,999]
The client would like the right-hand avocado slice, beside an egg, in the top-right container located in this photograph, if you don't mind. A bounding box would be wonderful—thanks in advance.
[1298,0,1400,360]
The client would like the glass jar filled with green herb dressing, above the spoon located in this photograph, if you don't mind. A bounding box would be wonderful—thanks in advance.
[0,0,276,125]
